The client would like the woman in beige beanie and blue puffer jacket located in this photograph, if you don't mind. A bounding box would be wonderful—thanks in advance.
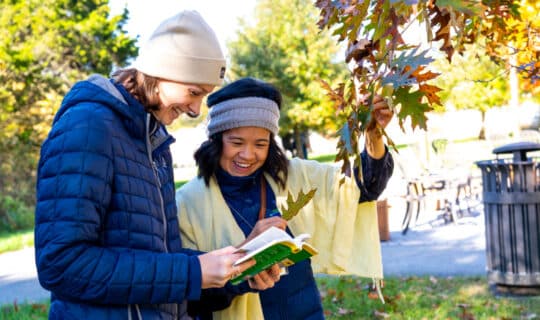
[35,11,277,319]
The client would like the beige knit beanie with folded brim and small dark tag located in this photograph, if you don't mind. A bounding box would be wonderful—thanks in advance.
[133,10,225,85]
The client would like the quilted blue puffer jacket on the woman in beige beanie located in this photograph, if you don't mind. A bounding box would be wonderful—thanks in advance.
[35,76,201,319]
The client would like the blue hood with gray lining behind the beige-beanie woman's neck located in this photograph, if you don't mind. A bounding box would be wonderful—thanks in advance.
[54,75,147,136]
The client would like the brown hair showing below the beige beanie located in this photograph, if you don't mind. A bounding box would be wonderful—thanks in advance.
[111,68,159,111]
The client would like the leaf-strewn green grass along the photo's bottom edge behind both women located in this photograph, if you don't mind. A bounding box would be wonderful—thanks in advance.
[4,277,540,320]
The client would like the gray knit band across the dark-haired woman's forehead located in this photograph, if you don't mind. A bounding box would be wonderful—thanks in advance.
[207,97,279,136]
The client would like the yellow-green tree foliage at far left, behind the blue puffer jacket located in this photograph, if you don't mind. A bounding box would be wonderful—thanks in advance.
[0,0,137,214]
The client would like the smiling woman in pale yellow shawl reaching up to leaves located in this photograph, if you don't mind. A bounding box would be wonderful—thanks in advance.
[177,78,393,320]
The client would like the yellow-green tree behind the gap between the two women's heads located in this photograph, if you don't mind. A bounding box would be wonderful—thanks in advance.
[228,0,346,140]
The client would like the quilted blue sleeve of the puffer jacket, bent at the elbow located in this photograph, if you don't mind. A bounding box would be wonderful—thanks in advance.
[35,104,200,304]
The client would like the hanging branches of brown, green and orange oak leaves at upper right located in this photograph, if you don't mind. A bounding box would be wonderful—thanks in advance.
[316,0,540,174]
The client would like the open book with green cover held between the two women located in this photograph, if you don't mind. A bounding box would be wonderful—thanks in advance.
[231,227,318,284]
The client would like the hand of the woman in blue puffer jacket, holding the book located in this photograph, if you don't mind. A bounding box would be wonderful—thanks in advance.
[198,246,256,289]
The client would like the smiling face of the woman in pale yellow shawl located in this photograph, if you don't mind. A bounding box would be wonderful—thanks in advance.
[219,127,270,177]
